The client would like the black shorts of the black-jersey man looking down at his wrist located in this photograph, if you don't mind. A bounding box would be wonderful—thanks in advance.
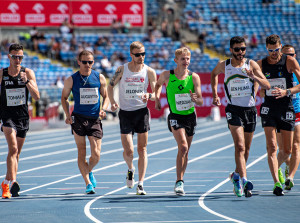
[260,103,296,131]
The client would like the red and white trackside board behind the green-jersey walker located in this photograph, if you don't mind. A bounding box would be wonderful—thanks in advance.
[148,73,262,118]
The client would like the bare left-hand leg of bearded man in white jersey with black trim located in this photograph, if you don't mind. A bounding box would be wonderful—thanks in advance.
[229,125,247,178]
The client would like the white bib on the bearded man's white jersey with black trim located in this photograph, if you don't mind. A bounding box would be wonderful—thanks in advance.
[230,78,252,97]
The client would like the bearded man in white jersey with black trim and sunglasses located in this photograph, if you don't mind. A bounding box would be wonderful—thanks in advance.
[211,36,270,197]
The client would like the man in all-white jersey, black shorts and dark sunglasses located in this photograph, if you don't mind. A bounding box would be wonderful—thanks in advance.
[108,41,156,195]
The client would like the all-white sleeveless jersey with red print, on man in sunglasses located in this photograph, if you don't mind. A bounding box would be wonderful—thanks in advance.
[119,63,149,111]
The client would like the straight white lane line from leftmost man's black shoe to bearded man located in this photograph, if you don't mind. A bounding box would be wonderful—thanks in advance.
[18,131,229,194]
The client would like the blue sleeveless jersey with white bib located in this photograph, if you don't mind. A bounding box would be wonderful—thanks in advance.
[72,70,101,118]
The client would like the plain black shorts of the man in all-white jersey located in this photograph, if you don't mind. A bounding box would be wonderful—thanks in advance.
[119,107,150,134]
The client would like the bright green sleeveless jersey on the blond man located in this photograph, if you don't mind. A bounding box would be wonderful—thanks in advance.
[166,70,195,115]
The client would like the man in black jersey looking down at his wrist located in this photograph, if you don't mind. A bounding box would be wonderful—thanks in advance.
[258,34,300,196]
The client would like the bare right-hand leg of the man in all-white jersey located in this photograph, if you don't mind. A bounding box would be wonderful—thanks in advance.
[137,132,148,181]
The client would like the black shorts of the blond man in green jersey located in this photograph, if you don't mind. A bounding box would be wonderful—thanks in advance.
[168,112,197,136]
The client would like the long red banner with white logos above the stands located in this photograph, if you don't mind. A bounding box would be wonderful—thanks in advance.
[0,0,146,27]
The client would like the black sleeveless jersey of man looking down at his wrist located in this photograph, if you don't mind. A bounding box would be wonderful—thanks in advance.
[262,55,293,108]
